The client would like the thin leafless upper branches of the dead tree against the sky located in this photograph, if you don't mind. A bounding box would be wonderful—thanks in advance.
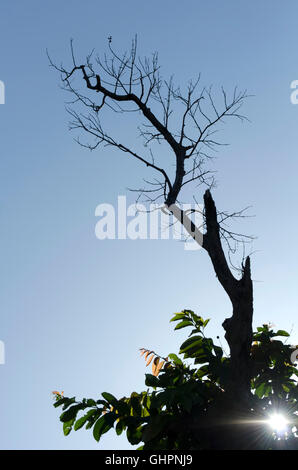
[49,37,250,266]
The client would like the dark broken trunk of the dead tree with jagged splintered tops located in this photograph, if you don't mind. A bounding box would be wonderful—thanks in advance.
[169,190,253,405]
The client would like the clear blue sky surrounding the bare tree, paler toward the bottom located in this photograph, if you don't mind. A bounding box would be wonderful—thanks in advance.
[0,0,298,449]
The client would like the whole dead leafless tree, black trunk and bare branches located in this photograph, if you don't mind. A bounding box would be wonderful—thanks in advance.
[49,38,253,401]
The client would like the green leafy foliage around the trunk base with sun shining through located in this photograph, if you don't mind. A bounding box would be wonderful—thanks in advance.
[54,310,298,450]
